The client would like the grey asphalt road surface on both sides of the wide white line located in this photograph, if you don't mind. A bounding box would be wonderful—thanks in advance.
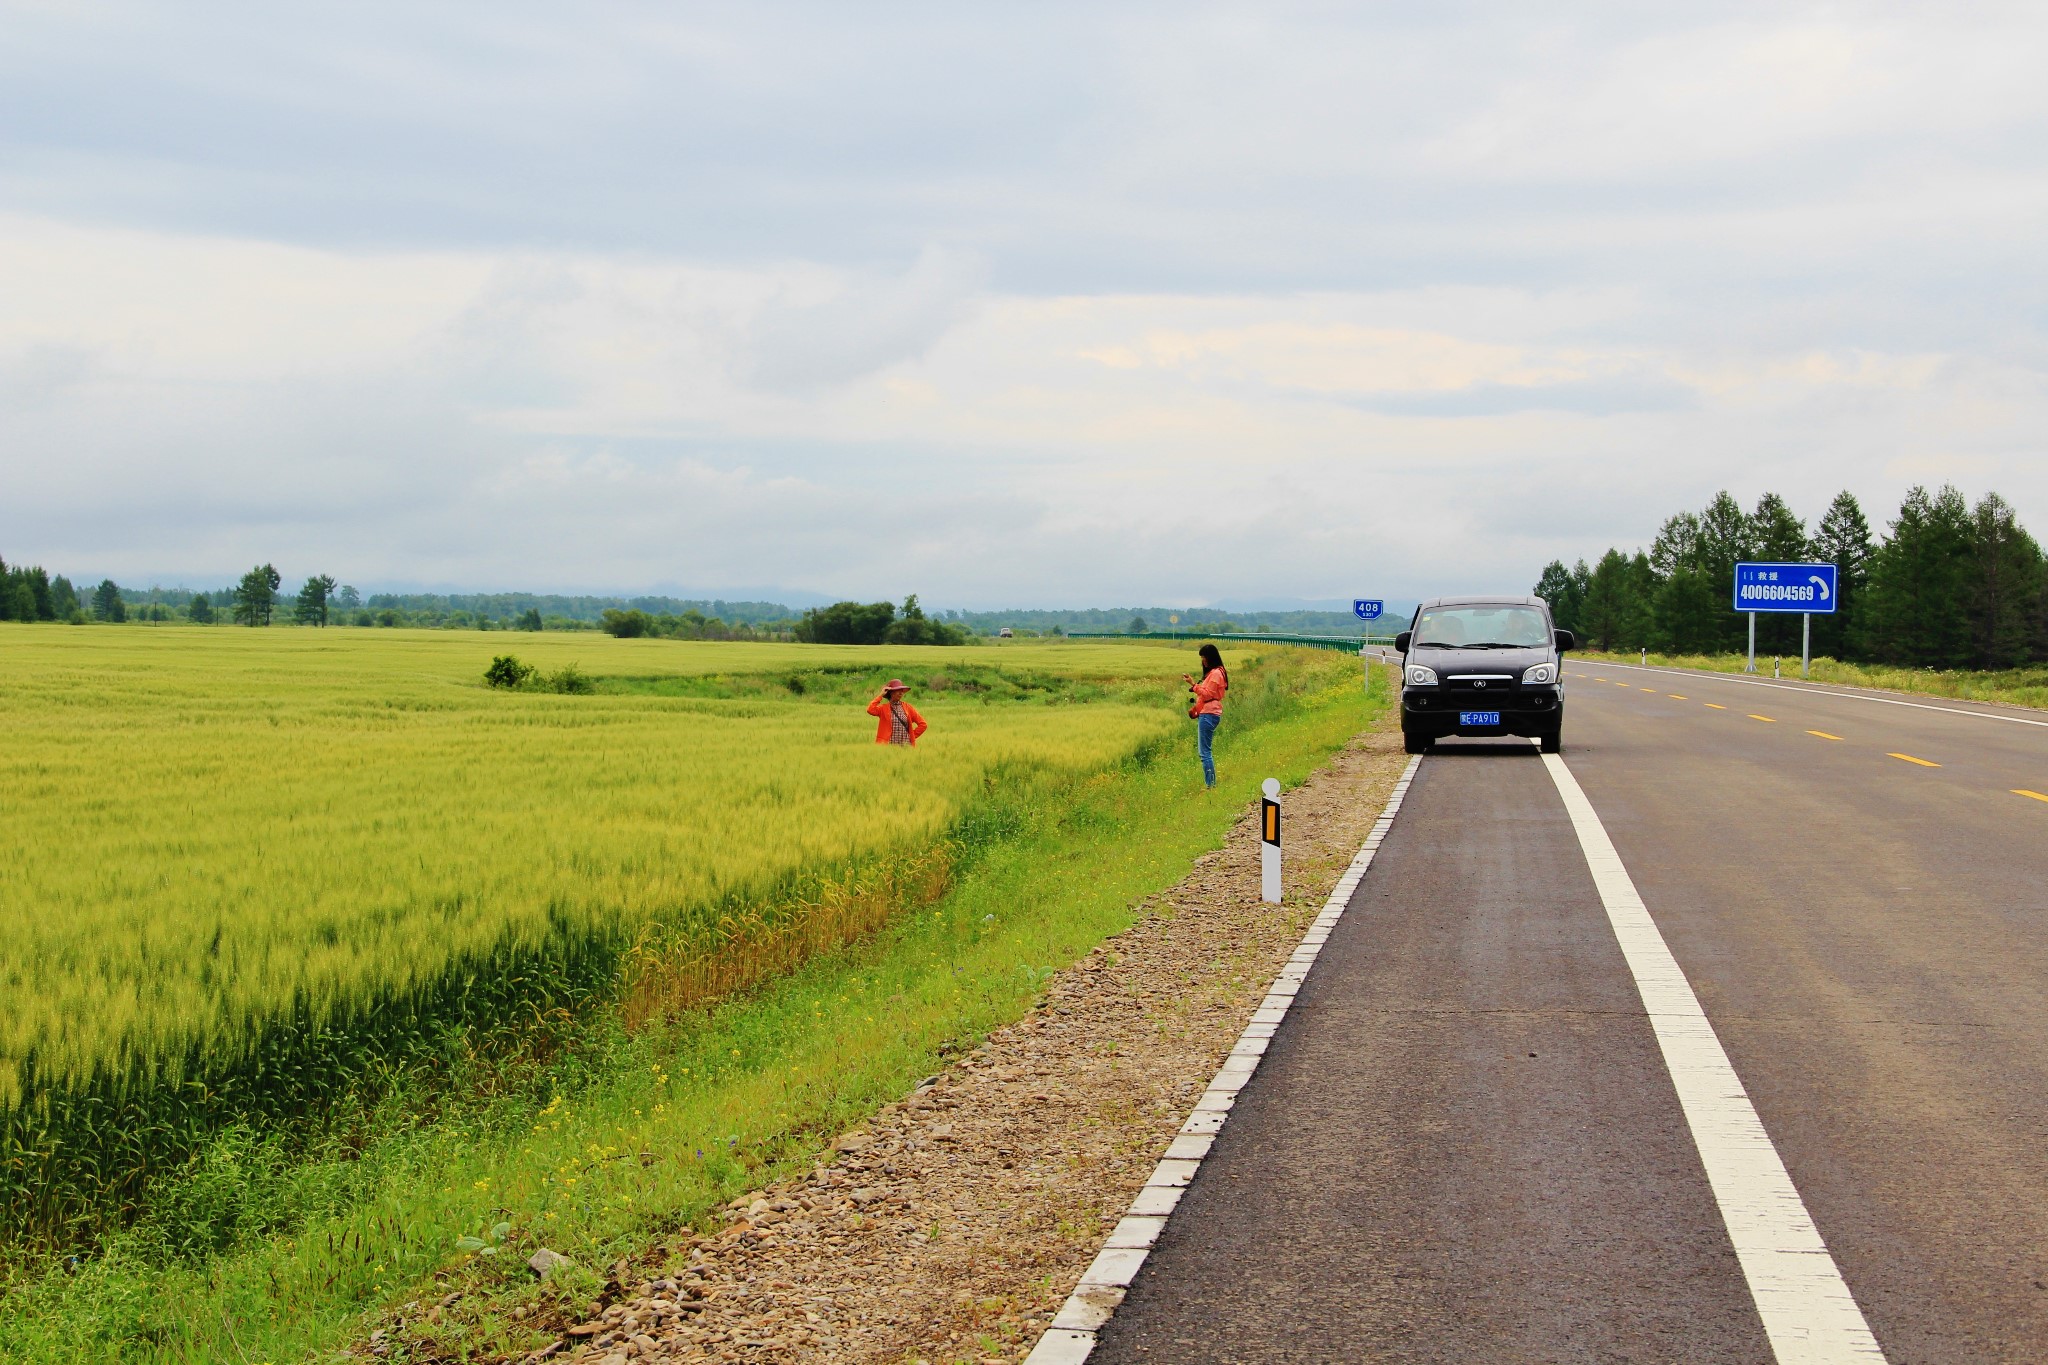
[1094,663,2048,1363]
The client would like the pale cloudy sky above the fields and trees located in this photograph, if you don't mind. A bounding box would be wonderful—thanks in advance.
[0,0,2048,608]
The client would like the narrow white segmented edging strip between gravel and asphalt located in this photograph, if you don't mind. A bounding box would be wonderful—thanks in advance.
[1024,755,1425,1365]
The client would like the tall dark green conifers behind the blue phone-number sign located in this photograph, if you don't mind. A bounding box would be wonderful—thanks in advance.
[1536,485,2048,669]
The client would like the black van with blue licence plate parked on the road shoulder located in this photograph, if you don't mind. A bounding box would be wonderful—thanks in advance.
[1395,598,1579,753]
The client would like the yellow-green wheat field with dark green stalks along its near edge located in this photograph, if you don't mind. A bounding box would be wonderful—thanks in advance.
[0,626,1310,1254]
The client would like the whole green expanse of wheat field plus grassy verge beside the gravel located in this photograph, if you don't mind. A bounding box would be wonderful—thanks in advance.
[0,626,1372,1361]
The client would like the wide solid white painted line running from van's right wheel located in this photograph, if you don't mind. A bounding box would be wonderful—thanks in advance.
[1542,753,1884,1365]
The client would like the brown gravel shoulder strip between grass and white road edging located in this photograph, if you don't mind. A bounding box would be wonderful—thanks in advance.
[526,729,1407,1365]
